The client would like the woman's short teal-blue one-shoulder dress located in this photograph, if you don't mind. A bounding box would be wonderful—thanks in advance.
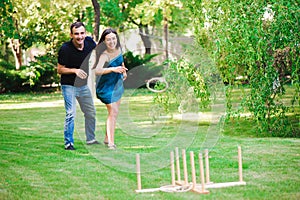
[96,53,124,104]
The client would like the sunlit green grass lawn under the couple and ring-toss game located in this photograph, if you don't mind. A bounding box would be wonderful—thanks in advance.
[0,90,300,200]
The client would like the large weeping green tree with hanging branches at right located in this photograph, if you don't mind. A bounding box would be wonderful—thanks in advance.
[187,0,300,136]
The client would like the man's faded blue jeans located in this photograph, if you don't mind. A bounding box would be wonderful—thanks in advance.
[61,85,96,147]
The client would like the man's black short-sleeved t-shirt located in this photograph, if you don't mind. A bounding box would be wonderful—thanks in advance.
[58,37,96,87]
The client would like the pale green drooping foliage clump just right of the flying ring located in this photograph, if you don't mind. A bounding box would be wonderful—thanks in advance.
[154,59,210,113]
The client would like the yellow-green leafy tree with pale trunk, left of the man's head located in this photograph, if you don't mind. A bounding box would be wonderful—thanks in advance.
[1,0,92,68]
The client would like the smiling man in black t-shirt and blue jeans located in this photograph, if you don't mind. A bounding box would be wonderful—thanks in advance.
[57,22,99,150]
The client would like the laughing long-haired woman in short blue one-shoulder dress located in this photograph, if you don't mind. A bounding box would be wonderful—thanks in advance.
[93,28,127,149]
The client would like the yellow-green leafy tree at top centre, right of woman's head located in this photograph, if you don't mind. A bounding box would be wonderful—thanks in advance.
[96,0,190,54]
